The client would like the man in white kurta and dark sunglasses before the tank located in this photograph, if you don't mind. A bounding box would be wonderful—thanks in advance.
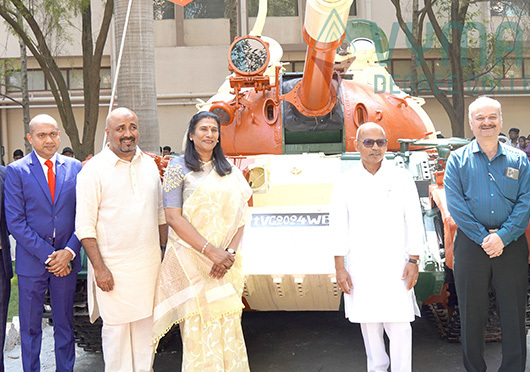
[330,123,424,372]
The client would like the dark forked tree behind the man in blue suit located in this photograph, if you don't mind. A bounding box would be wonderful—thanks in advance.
[0,0,114,159]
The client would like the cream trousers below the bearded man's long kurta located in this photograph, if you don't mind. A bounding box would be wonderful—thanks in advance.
[101,316,155,372]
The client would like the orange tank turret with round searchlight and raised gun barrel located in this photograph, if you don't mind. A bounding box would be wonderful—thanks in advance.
[202,0,434,155]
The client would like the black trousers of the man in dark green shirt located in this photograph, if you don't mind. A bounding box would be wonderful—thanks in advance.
[454,229,528,372]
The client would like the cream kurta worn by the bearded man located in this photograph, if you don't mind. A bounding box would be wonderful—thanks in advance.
[76,147,165,324]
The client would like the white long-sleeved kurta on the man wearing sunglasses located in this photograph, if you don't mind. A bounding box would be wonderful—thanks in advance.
[330,161,424,323]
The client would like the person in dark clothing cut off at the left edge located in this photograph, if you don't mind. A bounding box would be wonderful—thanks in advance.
[0,167,13,372]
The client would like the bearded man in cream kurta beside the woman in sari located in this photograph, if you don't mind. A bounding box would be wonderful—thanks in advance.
[76,108,167,372]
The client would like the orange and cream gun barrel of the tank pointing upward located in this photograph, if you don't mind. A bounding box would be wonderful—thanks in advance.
[295,0,353,116]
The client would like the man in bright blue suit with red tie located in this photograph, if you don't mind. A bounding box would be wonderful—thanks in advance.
[5,115,81,372]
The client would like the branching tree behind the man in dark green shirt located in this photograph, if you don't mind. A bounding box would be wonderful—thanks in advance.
[391,0,528,137]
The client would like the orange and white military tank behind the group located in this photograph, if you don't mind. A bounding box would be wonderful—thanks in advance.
[199,0,446,311]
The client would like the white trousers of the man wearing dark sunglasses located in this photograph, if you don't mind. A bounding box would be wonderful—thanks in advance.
[361,322,412,372]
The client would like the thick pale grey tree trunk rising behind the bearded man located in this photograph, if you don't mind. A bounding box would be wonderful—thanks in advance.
[115,0,160,154]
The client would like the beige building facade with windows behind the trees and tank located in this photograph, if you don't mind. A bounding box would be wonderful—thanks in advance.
[0,0,530,162]
